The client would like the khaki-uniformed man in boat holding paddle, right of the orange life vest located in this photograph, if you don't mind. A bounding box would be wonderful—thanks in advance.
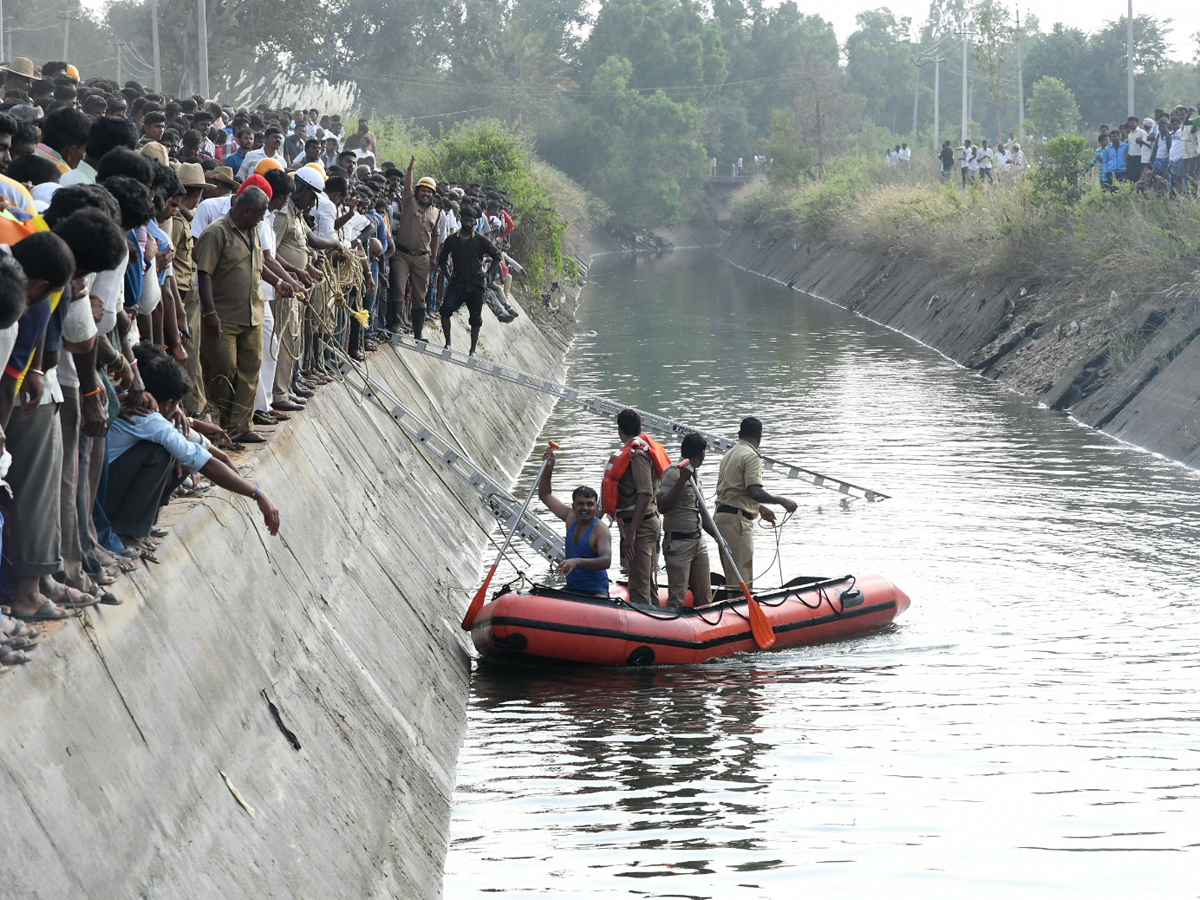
[659,433,716,606]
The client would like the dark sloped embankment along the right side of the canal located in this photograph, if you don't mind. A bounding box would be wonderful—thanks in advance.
[721,233,1200,467]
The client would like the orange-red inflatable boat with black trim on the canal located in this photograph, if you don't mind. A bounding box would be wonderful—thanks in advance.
[470,575,910,666]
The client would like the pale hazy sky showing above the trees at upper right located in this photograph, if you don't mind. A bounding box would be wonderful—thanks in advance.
[811,0,1200,61]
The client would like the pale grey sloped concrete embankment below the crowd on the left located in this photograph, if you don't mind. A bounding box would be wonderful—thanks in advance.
[0,307,565,900]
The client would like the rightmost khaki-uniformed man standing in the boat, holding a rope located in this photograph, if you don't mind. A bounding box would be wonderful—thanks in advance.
[713,415,796,586]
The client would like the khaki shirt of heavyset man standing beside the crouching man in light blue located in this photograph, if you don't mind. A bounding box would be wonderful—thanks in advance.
[194,214,263,326]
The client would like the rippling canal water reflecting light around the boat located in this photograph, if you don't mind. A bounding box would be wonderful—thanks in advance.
[445,251,1200,900]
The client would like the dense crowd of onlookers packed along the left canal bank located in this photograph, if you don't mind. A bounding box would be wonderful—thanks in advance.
[0,52,521,673]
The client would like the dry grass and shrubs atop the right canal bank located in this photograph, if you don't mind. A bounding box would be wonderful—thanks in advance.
[734,158,1200,319]
